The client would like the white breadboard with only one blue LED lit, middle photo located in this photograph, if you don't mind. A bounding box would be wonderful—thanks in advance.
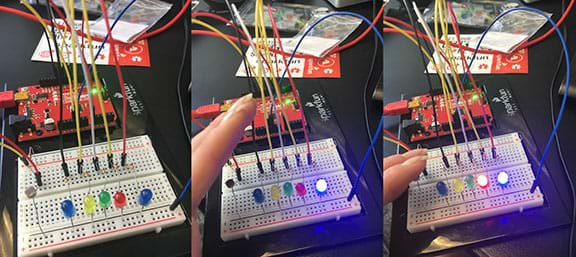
[220,139,361,241]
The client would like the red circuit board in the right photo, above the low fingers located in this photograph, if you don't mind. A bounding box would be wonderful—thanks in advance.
[402,90,493,142]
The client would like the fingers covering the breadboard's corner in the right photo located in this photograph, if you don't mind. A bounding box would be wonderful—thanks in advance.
[384,149,428,204]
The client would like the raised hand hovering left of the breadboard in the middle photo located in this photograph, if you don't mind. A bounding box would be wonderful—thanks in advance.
[191,94,256,257]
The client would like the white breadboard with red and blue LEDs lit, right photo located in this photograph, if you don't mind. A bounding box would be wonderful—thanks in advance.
[406,133,544,233]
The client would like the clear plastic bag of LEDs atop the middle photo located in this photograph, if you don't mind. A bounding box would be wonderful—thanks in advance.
[239,0,327,32]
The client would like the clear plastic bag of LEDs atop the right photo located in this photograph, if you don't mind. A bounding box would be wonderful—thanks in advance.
[424,0,523,29]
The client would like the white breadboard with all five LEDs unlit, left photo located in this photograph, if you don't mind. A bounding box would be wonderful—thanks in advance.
[17,136,186,256]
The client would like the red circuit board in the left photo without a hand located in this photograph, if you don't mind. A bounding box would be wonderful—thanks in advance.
[10,85,117,141]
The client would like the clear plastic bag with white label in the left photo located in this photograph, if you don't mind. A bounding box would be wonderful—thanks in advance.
[91,0,172,43]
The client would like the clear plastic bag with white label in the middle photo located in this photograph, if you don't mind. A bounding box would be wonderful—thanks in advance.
[284,12,362,57]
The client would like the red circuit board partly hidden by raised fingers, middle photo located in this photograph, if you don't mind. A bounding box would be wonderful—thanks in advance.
[222,92,306,143]
